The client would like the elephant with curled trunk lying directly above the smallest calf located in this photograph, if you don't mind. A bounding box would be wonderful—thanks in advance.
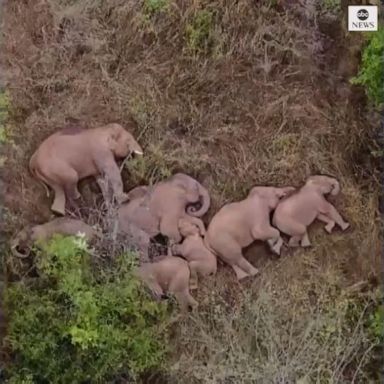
[119,173,210,243]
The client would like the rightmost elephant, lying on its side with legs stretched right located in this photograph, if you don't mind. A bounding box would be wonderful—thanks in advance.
[273,175,349,247]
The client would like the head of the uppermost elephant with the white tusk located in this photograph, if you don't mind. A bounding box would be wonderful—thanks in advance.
[107,124,143,157]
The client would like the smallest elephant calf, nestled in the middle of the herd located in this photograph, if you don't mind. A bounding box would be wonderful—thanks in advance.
[172,219,217,289]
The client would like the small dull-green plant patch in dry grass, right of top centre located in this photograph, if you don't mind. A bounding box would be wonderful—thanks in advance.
[186,9,214,54]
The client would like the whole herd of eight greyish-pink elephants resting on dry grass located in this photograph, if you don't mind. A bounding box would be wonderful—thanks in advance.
[11,123,349,310]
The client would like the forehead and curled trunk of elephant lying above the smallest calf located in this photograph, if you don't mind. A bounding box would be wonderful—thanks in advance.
[169,173,211,217]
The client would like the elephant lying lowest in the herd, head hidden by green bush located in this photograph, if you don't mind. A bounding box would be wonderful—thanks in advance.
[137,256,198,311]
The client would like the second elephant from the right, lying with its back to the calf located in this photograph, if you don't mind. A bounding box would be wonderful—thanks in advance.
[205,187,294,280]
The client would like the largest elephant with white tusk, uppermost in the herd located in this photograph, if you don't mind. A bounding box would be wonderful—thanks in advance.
[29,124,143,215]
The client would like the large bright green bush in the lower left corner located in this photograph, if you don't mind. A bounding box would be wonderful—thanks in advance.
[6,236,170,383]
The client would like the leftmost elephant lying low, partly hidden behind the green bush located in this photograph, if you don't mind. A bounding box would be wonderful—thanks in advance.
[11,217,101,258]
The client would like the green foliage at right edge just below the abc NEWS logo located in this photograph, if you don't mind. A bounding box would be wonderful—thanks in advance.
[351,28,384,108]
